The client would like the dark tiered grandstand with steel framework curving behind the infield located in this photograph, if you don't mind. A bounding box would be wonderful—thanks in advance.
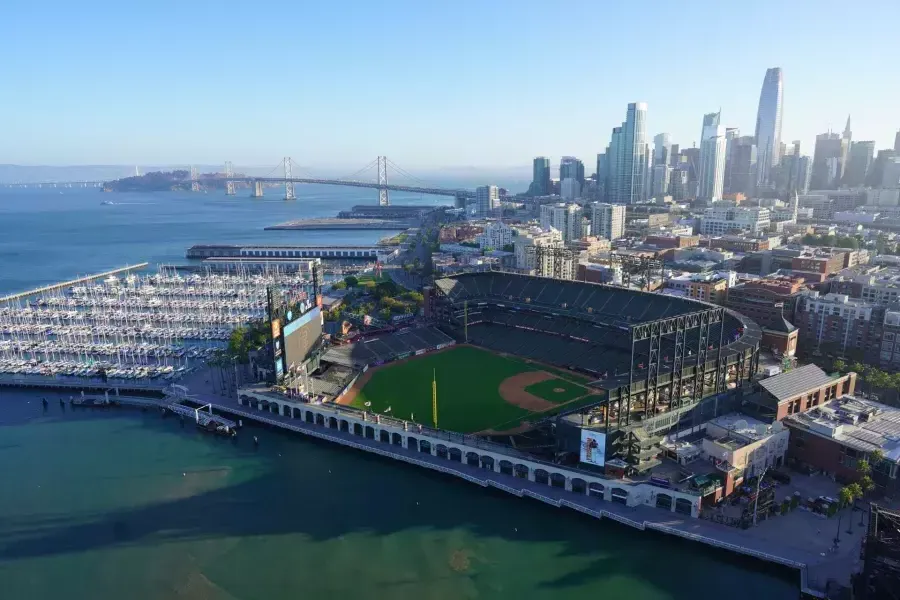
[430,271,761,469]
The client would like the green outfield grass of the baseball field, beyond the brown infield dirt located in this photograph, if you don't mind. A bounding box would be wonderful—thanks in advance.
[353,346,536,433]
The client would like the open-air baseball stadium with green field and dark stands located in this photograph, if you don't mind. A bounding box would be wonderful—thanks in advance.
[323,271,761,473]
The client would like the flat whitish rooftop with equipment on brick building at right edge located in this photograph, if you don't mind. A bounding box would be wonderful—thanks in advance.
[786,396,900,463]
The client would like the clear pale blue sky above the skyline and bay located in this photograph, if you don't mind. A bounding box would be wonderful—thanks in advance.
[7,0,900,172]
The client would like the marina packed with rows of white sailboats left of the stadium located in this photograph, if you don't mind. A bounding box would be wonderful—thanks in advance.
[0,268,307,389]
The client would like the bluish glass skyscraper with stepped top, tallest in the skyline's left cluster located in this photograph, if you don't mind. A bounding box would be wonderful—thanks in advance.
[607,102,649,204]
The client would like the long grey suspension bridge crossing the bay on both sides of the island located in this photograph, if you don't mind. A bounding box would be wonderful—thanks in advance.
[0,156,475,206]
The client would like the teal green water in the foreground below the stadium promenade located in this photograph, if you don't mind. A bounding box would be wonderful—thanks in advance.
[0,391,798,600]
